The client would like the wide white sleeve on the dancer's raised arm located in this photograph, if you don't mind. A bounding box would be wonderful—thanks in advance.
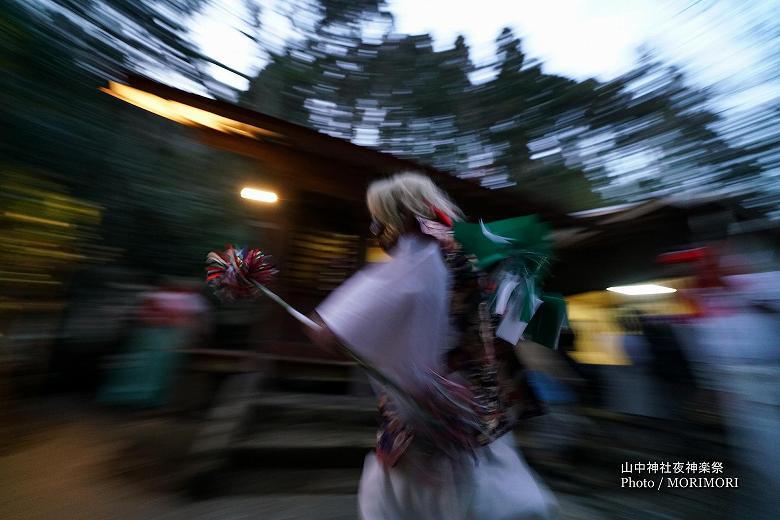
[317,237,449,387]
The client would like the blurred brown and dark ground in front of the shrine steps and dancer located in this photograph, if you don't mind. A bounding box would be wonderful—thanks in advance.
[0,403,744,520]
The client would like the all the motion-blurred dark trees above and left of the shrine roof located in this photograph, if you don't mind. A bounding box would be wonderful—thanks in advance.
[0,0,780,280]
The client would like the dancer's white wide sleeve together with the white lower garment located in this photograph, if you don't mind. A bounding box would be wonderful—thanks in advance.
[317,236,555,520]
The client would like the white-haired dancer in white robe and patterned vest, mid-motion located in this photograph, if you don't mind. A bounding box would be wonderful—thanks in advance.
[304,174,555,520]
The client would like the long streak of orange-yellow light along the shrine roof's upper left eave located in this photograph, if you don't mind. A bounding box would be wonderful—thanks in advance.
[100,81,281,138]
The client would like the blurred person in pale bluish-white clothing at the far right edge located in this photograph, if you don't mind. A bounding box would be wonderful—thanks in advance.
[684,251,780,518]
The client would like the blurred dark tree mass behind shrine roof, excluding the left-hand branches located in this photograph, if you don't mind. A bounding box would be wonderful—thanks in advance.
[240,2,780,210]
